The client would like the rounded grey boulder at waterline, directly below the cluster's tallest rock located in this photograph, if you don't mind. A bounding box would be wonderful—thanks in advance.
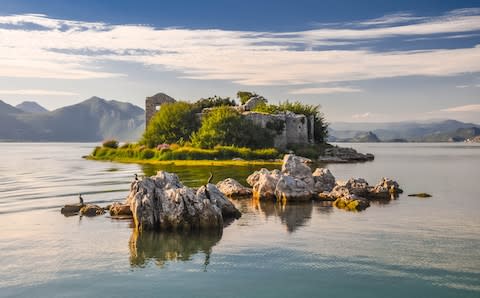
[275,175,313,201]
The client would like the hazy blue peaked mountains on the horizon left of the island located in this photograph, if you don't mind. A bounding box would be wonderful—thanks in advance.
[0,97,145,142]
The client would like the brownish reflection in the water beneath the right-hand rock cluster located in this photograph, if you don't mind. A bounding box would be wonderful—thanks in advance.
[250,199,314,233]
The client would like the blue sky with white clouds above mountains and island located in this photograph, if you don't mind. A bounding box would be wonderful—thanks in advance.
[0,0,480,123]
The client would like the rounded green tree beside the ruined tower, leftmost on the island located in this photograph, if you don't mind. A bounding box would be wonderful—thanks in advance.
[140,101,199,148]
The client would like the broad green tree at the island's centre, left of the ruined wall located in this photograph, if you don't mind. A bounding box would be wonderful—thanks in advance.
[192,106,273,148]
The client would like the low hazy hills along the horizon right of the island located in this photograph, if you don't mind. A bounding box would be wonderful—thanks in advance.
[329,120,480,142]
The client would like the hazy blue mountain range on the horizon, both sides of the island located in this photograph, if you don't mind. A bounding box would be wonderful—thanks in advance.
[0,96,480,142]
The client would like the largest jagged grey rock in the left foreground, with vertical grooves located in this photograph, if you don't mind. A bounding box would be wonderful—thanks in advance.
[126,171,240,231]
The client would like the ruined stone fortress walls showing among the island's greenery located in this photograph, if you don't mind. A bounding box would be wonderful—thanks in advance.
[145,93,315,150]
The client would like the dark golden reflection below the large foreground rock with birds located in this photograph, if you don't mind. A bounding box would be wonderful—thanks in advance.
[129,230,222,270]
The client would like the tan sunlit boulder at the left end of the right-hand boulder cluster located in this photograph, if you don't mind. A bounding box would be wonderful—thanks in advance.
[247,169,282,199]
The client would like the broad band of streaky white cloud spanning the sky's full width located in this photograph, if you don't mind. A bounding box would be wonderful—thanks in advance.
[0,10,480,85]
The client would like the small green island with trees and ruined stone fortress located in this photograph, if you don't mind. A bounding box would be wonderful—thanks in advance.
[86,91,373,165]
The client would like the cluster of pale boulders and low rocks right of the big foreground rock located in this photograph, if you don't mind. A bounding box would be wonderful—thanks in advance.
[237,154,402,210]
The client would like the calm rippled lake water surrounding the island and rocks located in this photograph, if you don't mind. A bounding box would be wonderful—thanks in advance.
[0,143,480,297]
